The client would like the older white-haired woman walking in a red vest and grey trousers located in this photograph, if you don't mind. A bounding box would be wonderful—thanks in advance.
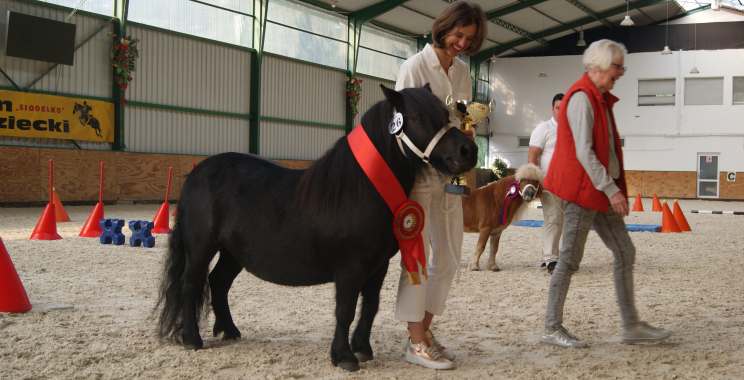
[540,40,672,348]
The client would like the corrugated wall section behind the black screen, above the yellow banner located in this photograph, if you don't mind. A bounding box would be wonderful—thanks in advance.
[0,2,114,98]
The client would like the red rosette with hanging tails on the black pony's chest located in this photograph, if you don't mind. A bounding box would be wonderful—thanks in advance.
[393,201,429,285]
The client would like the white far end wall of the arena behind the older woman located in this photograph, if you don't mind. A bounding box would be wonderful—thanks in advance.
[489,49,744,172]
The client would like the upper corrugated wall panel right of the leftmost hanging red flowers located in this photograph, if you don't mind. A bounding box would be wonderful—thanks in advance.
[126,26,251,115]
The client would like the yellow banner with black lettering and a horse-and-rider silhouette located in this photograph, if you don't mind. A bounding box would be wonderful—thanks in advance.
[0,90,114,143]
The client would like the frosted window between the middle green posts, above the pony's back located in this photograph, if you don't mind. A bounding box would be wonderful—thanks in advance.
[264,0,348,69]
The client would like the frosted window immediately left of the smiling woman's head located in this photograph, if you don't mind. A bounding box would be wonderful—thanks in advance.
[357,25,416,80]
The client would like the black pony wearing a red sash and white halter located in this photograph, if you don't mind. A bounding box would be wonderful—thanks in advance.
[156,84,478,371]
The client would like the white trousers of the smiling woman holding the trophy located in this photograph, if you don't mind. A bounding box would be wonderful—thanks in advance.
[395,168,463,322]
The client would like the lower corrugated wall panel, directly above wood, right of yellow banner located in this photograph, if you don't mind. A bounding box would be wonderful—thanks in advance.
[124,106,249,155]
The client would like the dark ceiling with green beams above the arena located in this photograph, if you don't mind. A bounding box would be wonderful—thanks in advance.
[303,0,728,57]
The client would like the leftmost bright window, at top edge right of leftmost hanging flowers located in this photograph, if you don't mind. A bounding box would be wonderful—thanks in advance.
[128,0,253,47]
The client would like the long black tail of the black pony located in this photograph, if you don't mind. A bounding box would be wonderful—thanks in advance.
[153,212,209,343]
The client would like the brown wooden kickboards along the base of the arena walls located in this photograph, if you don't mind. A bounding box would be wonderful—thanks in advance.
[0,146,744,203]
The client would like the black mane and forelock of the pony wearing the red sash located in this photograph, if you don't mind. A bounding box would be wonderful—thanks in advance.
[297,89,444,214]
